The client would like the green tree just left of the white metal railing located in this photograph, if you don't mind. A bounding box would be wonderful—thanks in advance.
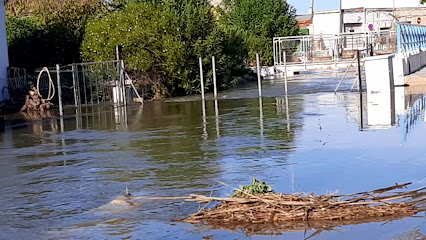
[219,0,299,64]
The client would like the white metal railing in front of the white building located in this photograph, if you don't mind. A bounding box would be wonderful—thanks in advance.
[273,31,397,66]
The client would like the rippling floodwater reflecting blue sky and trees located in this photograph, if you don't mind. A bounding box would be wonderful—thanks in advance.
[0,73,426,239]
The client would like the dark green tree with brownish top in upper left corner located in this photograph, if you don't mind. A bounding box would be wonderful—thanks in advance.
[6,0,102,71]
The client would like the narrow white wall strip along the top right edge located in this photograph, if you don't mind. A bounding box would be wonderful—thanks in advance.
[341,0,423,9]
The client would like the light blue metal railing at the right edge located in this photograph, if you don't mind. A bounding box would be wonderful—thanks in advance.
[396,23,426,53]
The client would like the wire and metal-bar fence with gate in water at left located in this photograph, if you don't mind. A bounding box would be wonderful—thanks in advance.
[7,60,143,115]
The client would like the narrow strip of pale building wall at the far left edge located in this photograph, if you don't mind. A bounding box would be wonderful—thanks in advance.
[0,0,9,101]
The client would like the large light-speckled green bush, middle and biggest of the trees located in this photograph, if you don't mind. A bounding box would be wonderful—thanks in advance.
[82,0,245,95]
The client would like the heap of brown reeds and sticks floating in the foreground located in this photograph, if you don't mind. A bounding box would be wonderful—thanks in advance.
[169,183,426,233]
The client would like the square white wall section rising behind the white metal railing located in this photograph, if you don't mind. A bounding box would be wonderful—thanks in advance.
[310,10,340,35]
